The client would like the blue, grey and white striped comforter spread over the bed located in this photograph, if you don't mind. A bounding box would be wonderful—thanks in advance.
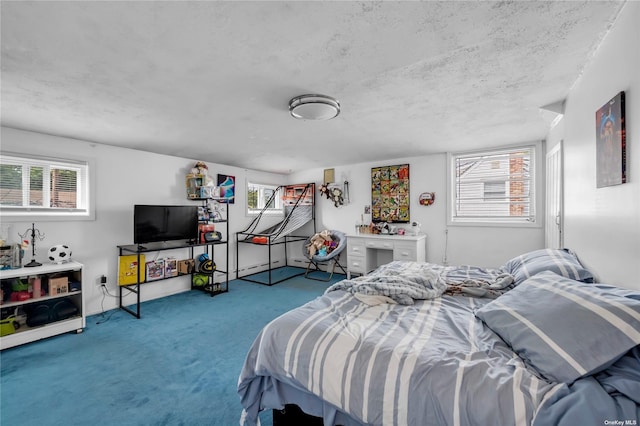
[238,262,640,426]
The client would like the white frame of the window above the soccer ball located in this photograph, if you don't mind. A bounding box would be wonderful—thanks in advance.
[0,151,95,222]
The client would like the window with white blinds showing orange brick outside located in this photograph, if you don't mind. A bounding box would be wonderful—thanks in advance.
[449,146,538,225]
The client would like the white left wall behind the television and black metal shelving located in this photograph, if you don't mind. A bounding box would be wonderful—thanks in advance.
[0,127,285,315]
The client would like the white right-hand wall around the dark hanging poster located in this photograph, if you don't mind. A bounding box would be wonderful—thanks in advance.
[548,2,640,289]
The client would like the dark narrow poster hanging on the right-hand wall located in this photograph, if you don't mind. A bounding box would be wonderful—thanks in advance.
[596,92,627,188]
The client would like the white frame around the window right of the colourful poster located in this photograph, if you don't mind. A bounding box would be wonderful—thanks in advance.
[447,141,544,228]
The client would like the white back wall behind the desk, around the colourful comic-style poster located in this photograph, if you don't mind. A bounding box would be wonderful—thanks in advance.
[290,153,544,267]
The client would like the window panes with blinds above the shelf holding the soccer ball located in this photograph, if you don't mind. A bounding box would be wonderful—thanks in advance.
[0,154,90,218]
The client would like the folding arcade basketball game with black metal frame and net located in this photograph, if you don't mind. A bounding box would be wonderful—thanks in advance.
[236,183,316,286]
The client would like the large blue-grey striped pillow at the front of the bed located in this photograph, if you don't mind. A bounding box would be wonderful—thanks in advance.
[476,271,640,383]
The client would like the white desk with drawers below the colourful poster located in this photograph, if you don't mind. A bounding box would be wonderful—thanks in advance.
[347,234,427,279]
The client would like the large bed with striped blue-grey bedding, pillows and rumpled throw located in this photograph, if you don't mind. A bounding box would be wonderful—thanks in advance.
[238,249,640,426]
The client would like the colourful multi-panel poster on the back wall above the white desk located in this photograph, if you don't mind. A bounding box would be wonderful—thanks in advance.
[371,164,410,223]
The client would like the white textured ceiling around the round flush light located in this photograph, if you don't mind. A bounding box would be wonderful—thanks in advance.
[0,1,623,173]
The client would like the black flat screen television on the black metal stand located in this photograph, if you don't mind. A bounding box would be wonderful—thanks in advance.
[133,204,198,244]
